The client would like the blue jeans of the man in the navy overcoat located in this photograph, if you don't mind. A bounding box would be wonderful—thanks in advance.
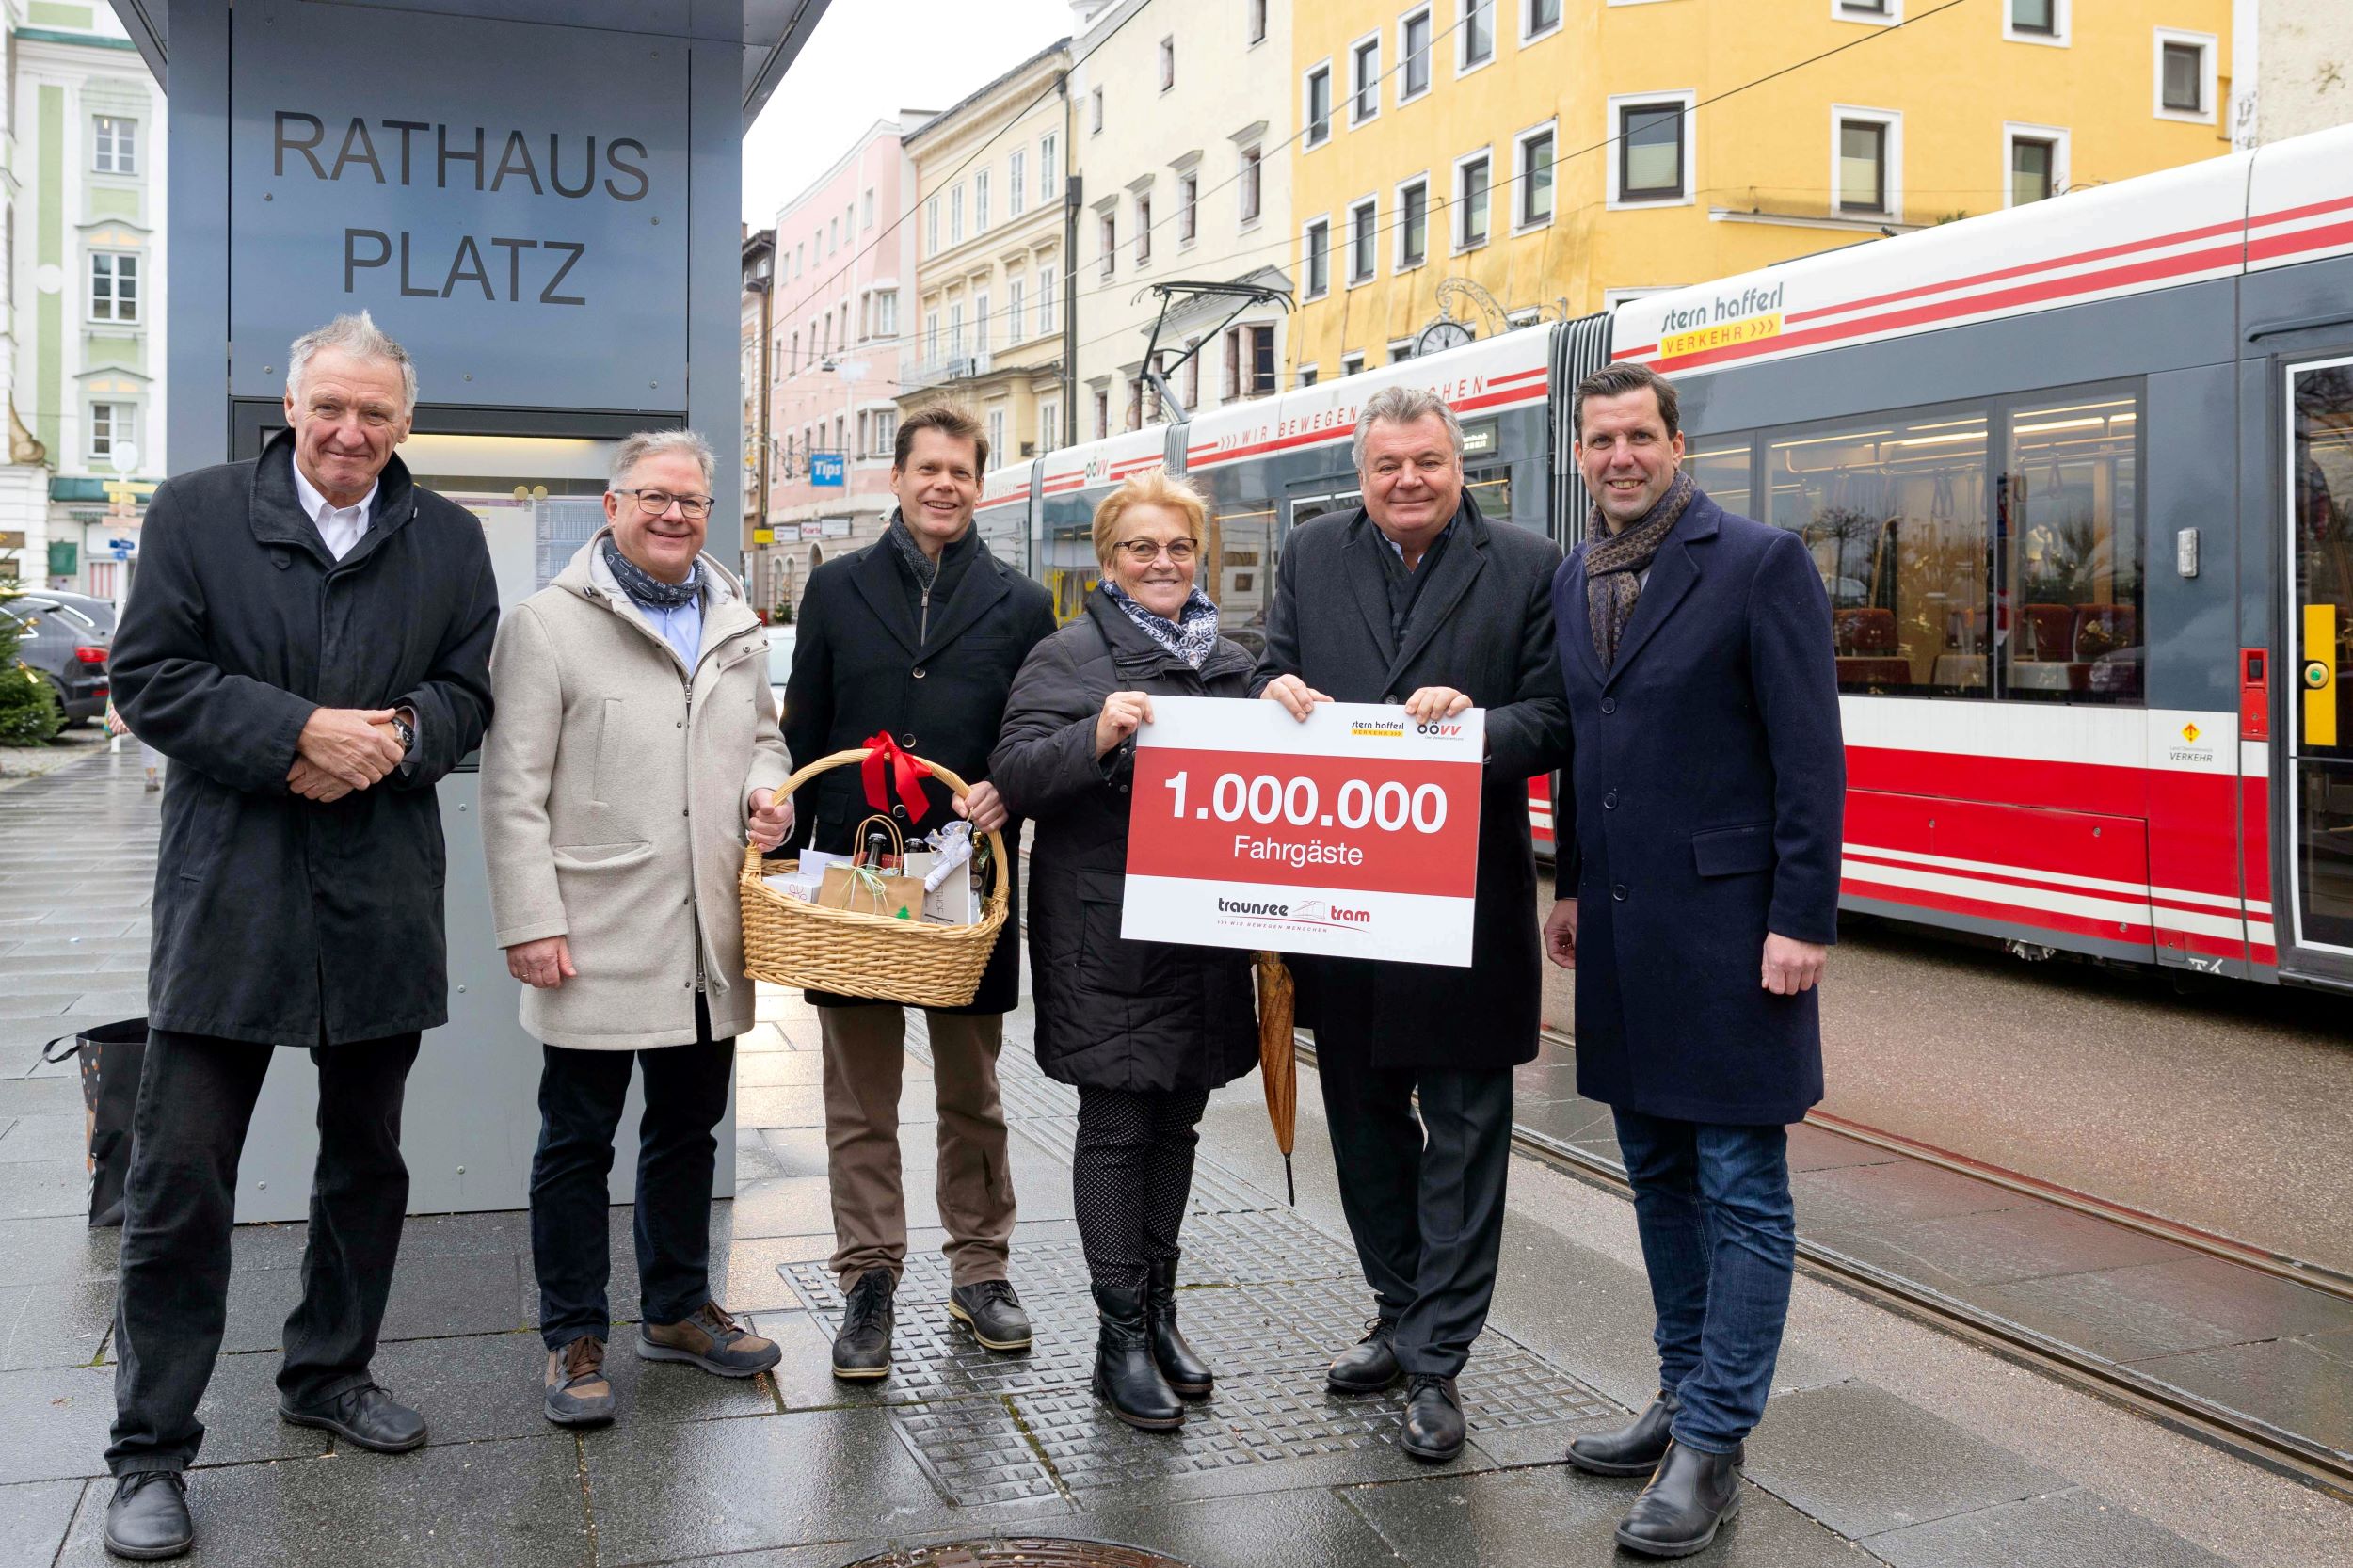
[1617,1112,1798,1452]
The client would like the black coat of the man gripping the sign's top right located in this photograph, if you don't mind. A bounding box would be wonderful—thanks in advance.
[1250,494,1570,1069]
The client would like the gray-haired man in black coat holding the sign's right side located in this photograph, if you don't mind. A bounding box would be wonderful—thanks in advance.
[1252,386,1570,1460]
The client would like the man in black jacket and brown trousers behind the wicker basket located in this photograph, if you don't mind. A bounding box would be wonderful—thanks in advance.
[784,408,1054,1380]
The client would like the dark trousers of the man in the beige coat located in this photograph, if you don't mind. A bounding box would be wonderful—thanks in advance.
[532,999,734,1352]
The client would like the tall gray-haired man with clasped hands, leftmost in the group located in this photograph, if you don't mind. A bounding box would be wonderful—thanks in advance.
[106,313,499,1559]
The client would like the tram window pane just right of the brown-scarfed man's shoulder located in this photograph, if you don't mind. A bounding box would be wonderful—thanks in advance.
[1769,408,1993,696]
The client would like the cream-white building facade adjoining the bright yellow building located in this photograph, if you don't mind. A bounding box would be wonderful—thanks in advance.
[1071,0,1294,440]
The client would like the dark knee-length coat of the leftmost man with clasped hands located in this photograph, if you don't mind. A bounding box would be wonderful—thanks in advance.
[111,436,499,1046]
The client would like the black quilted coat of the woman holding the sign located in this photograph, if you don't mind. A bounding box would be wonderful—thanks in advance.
[991,588,1259,1090]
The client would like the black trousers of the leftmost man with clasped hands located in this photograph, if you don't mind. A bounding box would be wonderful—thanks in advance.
[106,1029,419,1476]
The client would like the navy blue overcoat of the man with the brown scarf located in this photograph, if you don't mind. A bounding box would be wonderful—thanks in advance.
[1553,494,1848,1126]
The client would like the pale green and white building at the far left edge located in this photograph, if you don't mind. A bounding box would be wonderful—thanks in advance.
[0,0,168,600]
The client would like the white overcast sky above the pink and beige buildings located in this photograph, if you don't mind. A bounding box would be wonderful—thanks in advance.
[744,0,1071,229]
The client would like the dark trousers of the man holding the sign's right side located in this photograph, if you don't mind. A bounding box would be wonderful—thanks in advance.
[1316,1029,1511,1377]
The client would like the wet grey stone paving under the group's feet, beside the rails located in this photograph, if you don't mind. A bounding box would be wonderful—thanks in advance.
[0,756,2353,1568]
